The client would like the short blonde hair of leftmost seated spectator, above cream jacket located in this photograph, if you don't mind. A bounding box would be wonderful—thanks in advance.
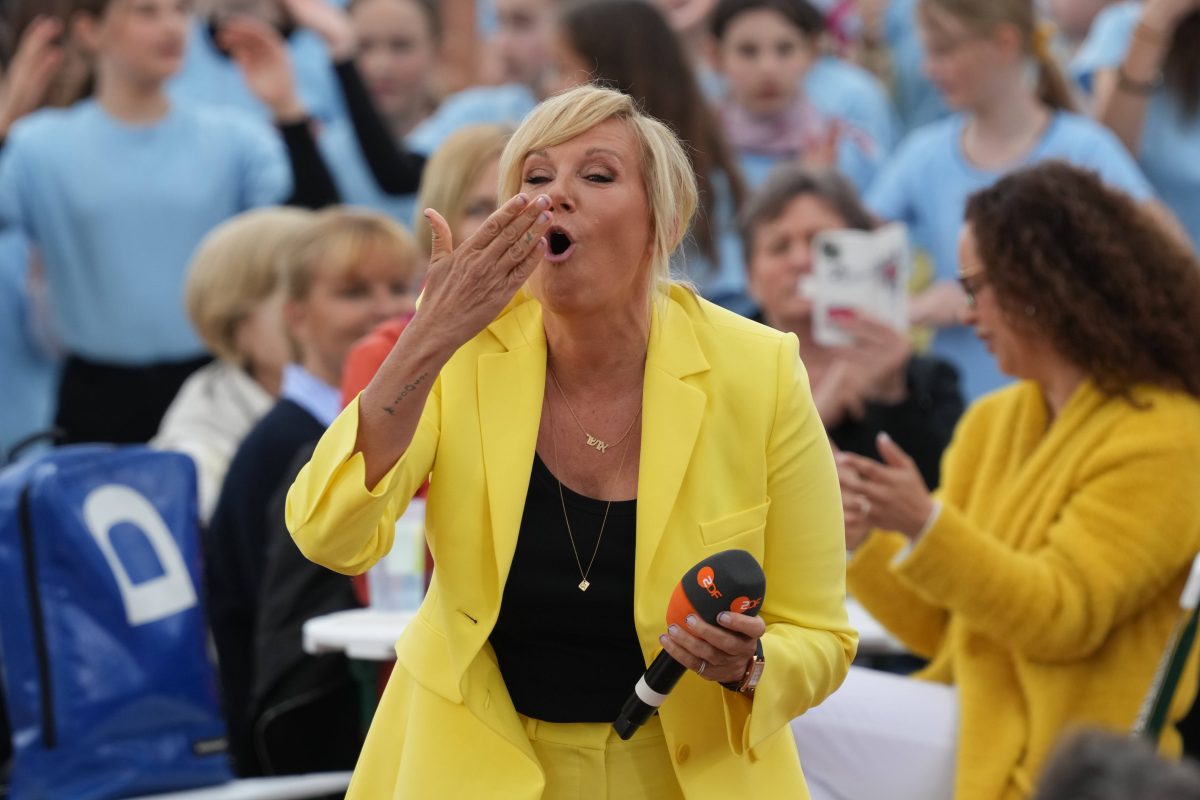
[184,207,314,366]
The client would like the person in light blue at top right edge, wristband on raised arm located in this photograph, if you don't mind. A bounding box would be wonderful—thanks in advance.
[1072,0,1200,251]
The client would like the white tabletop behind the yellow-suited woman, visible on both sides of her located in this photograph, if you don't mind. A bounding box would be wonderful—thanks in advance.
[304,597,906,661]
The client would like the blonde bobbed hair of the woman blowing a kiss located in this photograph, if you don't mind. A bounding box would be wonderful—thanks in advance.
[499,85,697,307]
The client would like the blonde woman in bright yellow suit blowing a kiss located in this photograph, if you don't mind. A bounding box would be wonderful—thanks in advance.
[287,88,857,800]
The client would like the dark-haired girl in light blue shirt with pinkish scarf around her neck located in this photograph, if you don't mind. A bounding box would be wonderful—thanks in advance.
[712,0,890,188]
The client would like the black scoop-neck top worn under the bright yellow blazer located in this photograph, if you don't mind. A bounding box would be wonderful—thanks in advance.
[491,455,646,722]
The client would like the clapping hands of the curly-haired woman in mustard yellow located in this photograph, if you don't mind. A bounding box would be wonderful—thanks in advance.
[835,433,934,549]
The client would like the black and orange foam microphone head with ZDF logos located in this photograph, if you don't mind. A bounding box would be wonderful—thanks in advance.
[667,551,767,625]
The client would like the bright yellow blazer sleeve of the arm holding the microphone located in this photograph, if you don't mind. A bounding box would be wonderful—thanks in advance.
[722,335,858,753]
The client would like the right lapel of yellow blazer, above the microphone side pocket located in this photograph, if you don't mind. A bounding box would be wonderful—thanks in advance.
[634,300,709,587]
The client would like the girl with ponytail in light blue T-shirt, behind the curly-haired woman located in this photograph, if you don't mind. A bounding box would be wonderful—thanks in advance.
[866,0,1153,399]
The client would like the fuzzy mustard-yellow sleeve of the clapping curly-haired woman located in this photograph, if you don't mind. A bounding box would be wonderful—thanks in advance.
[895,413,1200,662]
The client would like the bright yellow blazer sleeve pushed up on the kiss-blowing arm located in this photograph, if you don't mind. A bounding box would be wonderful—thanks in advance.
[286,379,442,575]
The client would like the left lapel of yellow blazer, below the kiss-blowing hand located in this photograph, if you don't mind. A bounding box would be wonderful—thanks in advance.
[476,302,546,594]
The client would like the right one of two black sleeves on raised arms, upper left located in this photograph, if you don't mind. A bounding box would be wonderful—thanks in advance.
[334,59,425,196]
